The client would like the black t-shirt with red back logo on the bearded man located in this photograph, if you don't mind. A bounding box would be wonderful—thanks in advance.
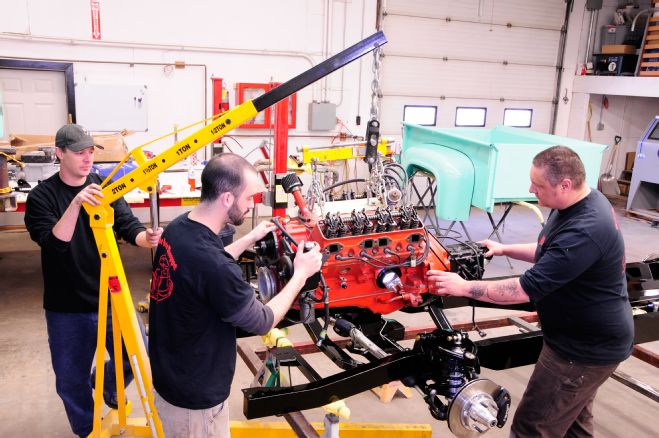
[149,213,273,409]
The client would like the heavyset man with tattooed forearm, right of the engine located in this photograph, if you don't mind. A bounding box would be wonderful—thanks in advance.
[428,146,634,437]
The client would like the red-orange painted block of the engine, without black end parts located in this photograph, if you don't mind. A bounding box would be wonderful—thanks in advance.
[262,209,450,314]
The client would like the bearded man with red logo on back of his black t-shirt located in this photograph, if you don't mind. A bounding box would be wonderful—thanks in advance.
[149,154,321,437]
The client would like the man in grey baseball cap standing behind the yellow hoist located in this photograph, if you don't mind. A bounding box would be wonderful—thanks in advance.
[25,125,163,437]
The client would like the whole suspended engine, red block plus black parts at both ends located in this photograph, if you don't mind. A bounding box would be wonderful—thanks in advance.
[255,175,483,314]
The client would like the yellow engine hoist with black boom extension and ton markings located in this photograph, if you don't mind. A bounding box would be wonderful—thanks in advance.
[83,32,387,437]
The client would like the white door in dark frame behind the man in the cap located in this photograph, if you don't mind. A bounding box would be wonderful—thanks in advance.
[0,68,67,136]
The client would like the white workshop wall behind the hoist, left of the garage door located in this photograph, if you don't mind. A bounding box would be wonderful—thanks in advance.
[0,0,376,158]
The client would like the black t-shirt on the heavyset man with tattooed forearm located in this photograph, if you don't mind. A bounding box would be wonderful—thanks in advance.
[520,190,634,364]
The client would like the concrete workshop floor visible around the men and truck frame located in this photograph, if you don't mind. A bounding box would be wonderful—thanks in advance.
[0,206,659,437]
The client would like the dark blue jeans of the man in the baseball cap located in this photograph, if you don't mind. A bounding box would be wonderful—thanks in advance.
[46,309,133,437]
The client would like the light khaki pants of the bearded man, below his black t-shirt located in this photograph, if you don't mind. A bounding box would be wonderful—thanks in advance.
[153,391,231,438]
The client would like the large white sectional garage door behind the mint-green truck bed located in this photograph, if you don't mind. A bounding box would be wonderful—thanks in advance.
[380,0,565,135]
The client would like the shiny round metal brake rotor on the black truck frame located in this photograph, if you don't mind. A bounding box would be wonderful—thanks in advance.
[448,379,501,438]
